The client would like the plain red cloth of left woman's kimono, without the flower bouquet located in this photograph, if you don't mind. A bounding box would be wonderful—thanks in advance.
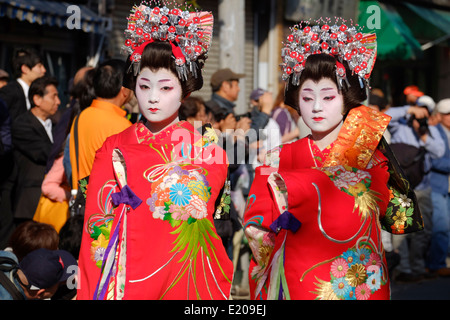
[78,122,233,299]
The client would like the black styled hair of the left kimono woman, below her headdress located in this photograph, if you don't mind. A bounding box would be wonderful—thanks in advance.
[123,41,206,100]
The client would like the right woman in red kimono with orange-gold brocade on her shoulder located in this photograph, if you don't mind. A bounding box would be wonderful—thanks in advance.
[244,22,422,300]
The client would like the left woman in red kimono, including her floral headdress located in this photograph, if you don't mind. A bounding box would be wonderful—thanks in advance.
[78,5,233,300]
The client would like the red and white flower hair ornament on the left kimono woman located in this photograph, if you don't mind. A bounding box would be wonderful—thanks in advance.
[122,2,214,80]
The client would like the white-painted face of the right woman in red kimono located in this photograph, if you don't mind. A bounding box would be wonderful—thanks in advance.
[299,78,344,149]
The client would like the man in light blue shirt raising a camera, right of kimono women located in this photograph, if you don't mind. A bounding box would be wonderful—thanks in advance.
[386,86,445,282]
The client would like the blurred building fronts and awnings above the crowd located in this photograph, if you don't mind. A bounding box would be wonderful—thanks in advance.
[0,0,450,114]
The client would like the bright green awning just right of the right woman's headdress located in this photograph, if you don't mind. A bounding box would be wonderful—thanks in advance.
[358,1,422,60]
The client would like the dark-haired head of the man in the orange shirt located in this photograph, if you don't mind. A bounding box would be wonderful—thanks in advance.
[93,59,125,99]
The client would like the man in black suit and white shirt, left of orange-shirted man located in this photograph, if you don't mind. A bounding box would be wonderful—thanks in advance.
[11,76,61,223]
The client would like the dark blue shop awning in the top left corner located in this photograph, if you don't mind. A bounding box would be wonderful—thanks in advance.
[0,0,110,33]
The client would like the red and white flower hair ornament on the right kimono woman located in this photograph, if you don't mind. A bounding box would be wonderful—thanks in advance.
[281,19,377,88]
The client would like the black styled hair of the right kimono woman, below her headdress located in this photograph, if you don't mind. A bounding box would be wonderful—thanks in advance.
[284,53,367,116]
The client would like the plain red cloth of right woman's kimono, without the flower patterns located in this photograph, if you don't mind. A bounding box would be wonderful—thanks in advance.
[245,137,390,299]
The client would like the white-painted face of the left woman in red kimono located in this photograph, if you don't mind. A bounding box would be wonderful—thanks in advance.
[135,68,182,133]
